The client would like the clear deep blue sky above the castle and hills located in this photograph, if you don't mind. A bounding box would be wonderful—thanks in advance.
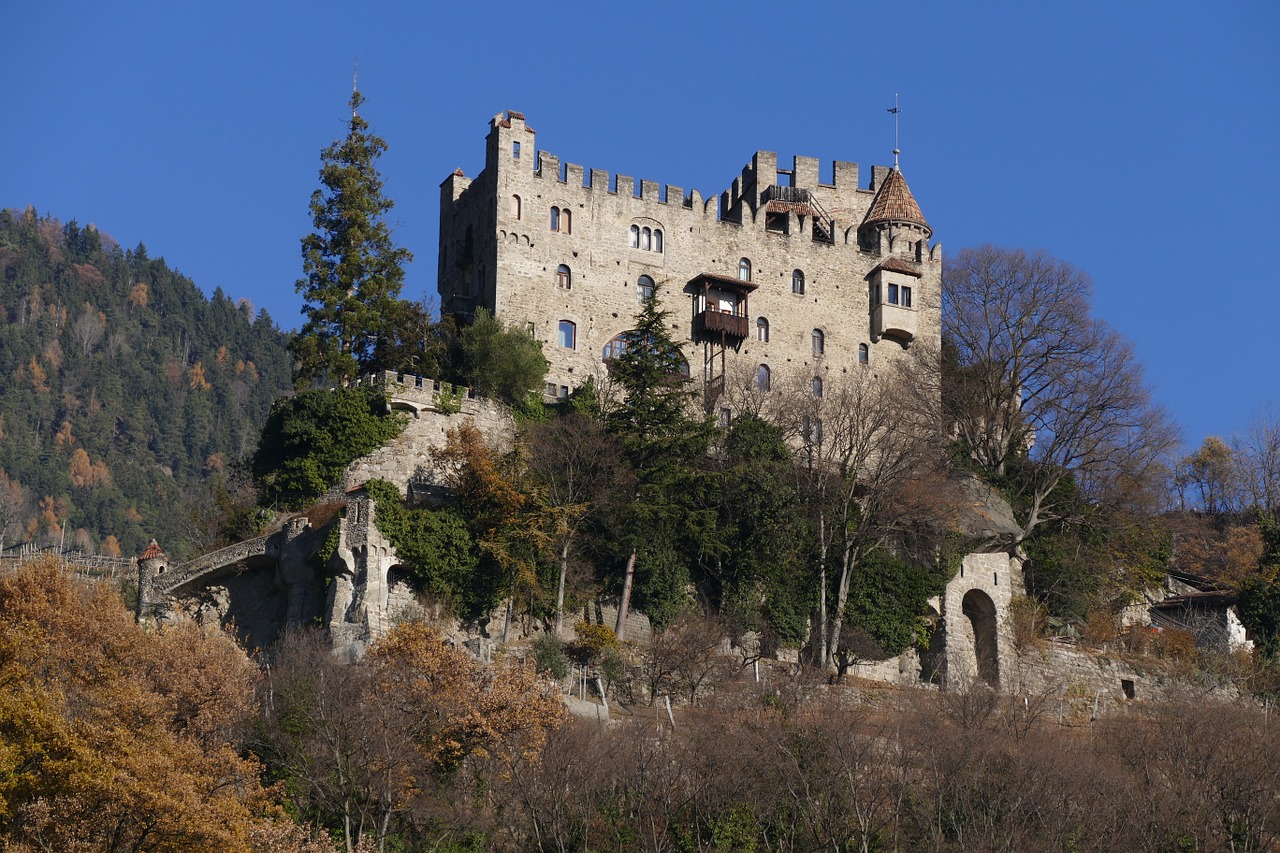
[0,0,1280,444]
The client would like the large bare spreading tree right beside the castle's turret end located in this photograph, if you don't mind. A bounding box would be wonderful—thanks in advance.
[942,245,1176,537]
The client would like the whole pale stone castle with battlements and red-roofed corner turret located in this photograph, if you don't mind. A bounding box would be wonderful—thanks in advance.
[439,111,942,406]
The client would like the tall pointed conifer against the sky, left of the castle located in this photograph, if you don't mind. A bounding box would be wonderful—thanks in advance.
[291,91,413,388]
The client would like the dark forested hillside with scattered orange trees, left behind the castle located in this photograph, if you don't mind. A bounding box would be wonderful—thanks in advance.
[0,209,291,557]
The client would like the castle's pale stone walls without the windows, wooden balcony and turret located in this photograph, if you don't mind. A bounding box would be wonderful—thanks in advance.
[439,114,941,399]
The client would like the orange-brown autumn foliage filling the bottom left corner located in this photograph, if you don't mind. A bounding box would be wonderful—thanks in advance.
[0,561,312,853]
